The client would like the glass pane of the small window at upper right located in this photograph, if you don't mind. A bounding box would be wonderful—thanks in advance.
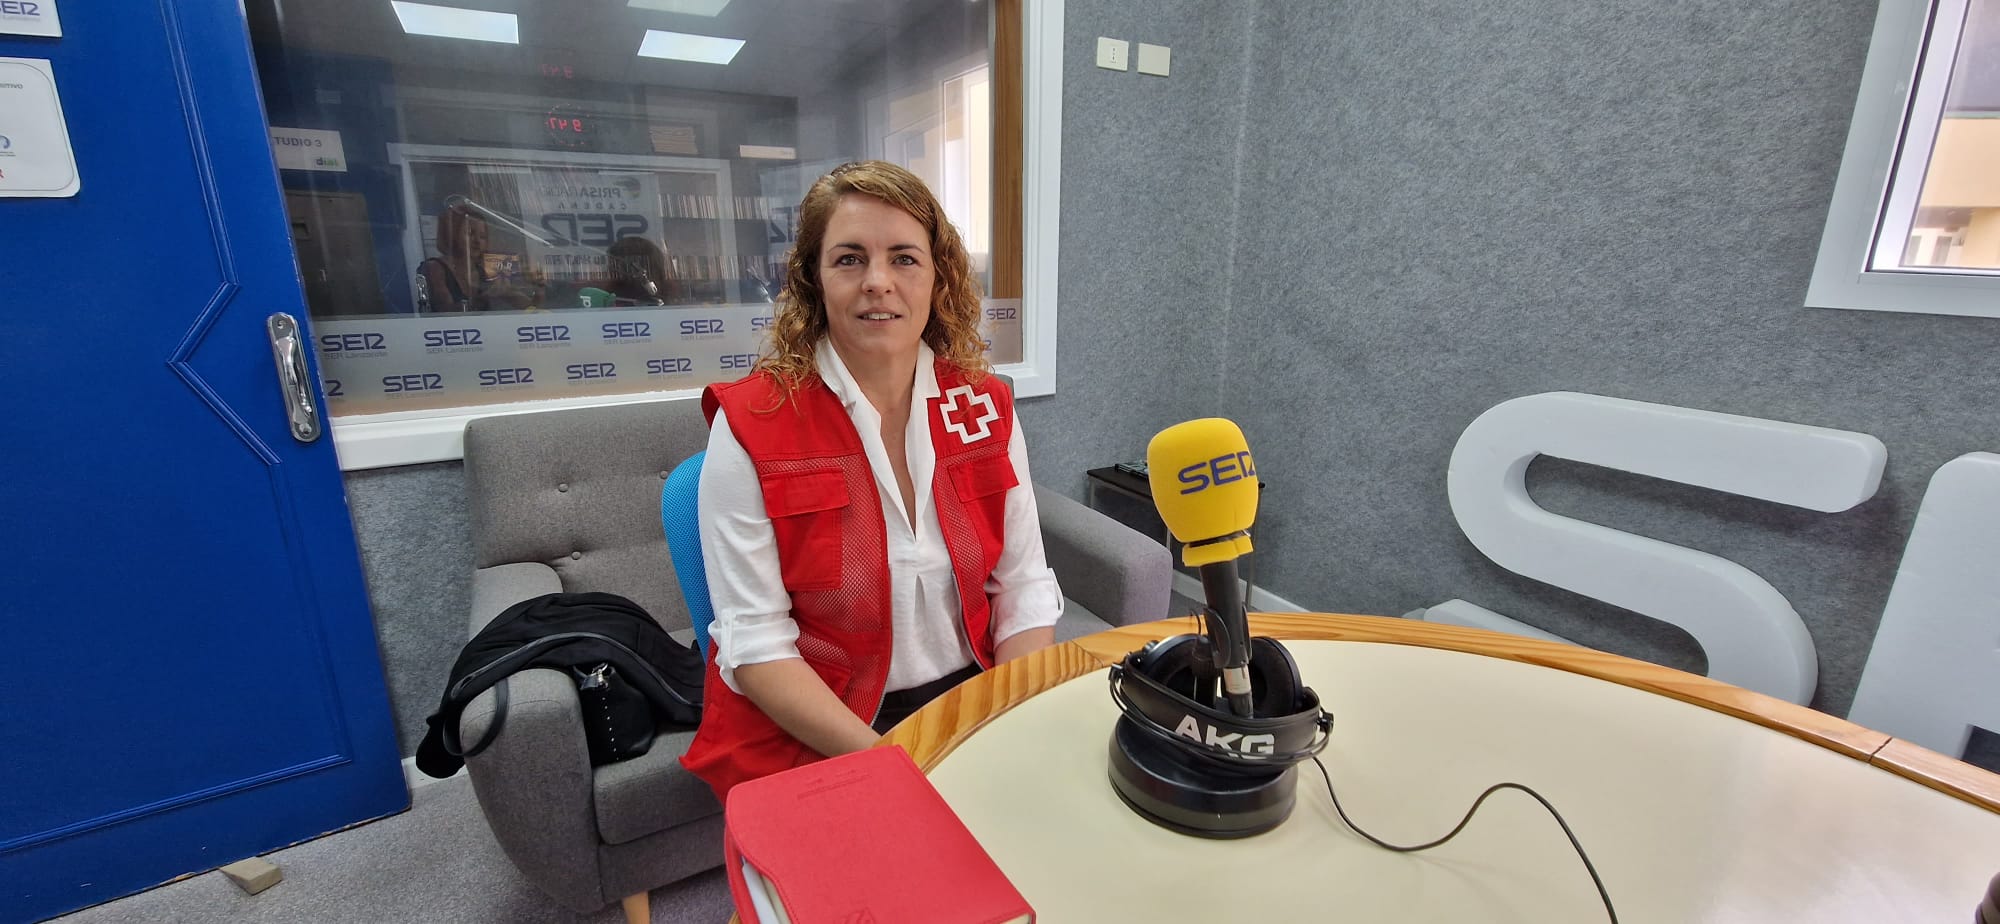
[1898,0,2000,270]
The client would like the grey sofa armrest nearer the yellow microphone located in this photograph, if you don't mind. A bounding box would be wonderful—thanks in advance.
[1034,484,1174,626]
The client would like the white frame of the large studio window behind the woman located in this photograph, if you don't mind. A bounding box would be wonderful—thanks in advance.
[314,0,1064,472]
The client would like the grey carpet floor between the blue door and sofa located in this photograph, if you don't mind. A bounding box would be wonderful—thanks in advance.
[56,776,732,924]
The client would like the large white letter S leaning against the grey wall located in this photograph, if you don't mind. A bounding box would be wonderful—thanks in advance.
[1426,392,1888,702]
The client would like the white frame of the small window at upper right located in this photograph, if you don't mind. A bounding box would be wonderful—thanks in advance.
[1806,0,2000,318]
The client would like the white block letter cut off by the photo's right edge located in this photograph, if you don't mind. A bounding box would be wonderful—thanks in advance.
[1848,452,2000,756]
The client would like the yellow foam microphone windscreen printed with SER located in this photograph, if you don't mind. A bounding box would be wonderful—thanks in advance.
[1146,418,1258,566]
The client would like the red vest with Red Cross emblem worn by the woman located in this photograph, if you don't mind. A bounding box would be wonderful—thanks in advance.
[680,362,1020,798]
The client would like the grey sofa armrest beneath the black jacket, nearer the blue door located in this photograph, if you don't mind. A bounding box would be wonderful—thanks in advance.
[458,668,604,912]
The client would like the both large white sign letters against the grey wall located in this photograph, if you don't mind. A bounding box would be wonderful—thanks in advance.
[1424,392,2000,754]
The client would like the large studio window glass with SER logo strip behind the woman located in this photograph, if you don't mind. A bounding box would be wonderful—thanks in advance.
[248,0,1020,414]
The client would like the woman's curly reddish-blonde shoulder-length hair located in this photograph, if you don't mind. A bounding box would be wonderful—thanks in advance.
[756,160,988,394]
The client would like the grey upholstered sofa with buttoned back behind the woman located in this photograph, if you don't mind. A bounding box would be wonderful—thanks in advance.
[460,400,1172,920]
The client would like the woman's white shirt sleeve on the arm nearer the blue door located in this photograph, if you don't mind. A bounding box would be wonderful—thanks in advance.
[696,410,800,692]
